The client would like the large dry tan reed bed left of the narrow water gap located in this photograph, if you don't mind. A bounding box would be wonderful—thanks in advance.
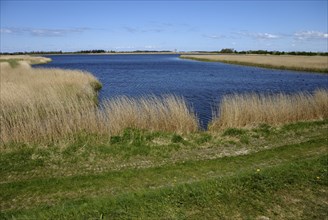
[0,64,198,143]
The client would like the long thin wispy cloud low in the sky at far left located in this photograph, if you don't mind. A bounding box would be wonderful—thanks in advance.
[0,28,90,37]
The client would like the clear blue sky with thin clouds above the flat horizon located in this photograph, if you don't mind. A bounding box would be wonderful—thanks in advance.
[0,0,328,52]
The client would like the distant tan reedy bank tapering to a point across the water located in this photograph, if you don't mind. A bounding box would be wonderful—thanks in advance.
[180,55,328,73]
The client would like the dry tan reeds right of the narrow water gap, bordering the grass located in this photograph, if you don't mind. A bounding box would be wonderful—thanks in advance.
[209,89,328,131]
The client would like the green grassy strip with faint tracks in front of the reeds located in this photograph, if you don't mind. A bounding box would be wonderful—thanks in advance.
[0,121,328,219]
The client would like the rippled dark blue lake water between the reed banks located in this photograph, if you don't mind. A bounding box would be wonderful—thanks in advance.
[37,55,328,127]
